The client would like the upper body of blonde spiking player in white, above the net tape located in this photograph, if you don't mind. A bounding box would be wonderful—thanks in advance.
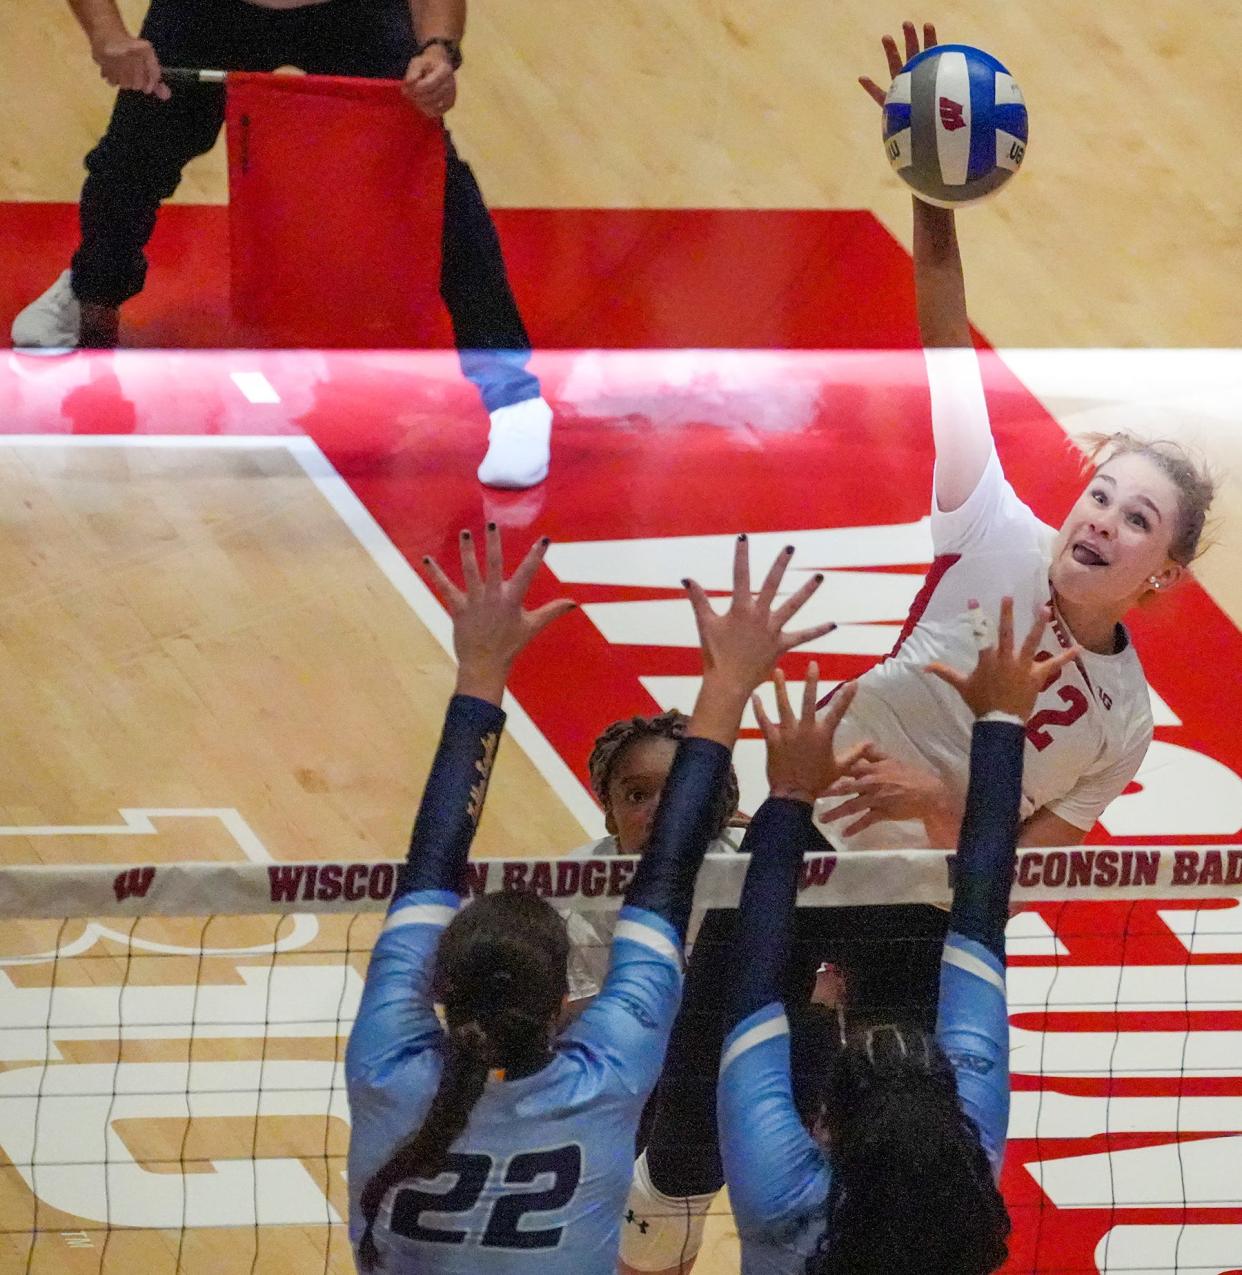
[825,23,1213,849]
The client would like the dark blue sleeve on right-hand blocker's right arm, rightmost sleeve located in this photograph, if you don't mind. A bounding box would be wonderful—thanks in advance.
[949,722,1025,961]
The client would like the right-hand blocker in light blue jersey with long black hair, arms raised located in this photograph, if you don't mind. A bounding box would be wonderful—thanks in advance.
[718,598,1074,1275]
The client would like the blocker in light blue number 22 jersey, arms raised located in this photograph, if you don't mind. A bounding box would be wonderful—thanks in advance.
[346,525,831,1275]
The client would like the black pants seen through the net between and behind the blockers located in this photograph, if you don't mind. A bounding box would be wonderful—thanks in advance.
[644,904,949,1197]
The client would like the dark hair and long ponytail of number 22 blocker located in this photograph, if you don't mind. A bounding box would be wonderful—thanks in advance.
[358,894,569,1271]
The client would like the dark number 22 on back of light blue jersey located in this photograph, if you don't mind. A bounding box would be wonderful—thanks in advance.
[390,1142,583,1248]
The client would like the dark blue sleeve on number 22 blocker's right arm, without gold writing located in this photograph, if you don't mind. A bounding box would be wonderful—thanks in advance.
[625,738,731,944]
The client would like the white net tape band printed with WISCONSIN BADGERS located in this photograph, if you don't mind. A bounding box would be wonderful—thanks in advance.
[0,845,1242,918]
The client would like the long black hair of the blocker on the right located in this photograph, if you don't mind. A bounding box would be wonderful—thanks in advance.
[806,1024,1010,1275]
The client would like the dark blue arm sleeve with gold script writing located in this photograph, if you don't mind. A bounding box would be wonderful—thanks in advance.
[397,695,505,895]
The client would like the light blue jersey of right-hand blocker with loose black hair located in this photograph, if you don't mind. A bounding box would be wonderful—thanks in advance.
[717,931,1009,1275]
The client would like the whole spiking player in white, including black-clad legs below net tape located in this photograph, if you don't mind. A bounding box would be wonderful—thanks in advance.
[622,23,1213,1275]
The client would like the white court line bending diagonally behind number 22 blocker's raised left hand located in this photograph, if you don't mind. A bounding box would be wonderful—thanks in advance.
[0,434,604,839]
